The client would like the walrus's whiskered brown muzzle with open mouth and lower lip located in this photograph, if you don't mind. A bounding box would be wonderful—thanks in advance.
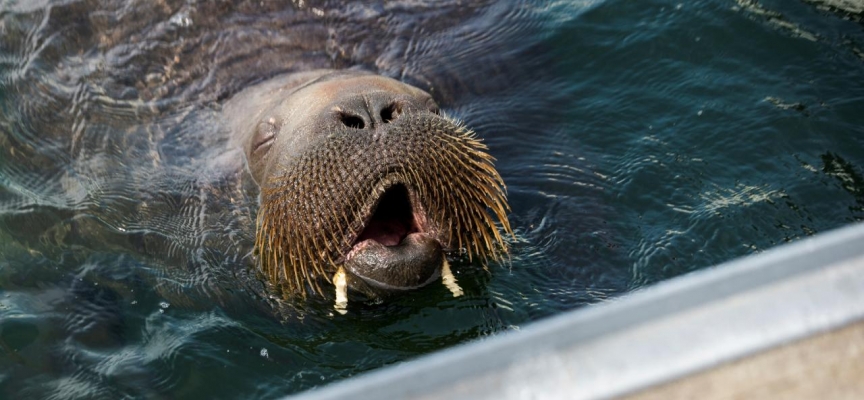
[255,111,512,296]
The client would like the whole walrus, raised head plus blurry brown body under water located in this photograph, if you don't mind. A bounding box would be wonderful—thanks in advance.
[0,0,536,314]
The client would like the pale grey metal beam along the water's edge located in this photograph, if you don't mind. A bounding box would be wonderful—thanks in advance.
[288,224,864,400]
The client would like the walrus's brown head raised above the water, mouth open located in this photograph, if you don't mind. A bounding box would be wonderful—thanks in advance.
[224,70,510,296]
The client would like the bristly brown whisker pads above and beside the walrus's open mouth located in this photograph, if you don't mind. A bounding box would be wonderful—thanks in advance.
[255,112,512,296]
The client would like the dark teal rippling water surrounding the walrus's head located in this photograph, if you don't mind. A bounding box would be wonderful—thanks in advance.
[0,0,864,398]
